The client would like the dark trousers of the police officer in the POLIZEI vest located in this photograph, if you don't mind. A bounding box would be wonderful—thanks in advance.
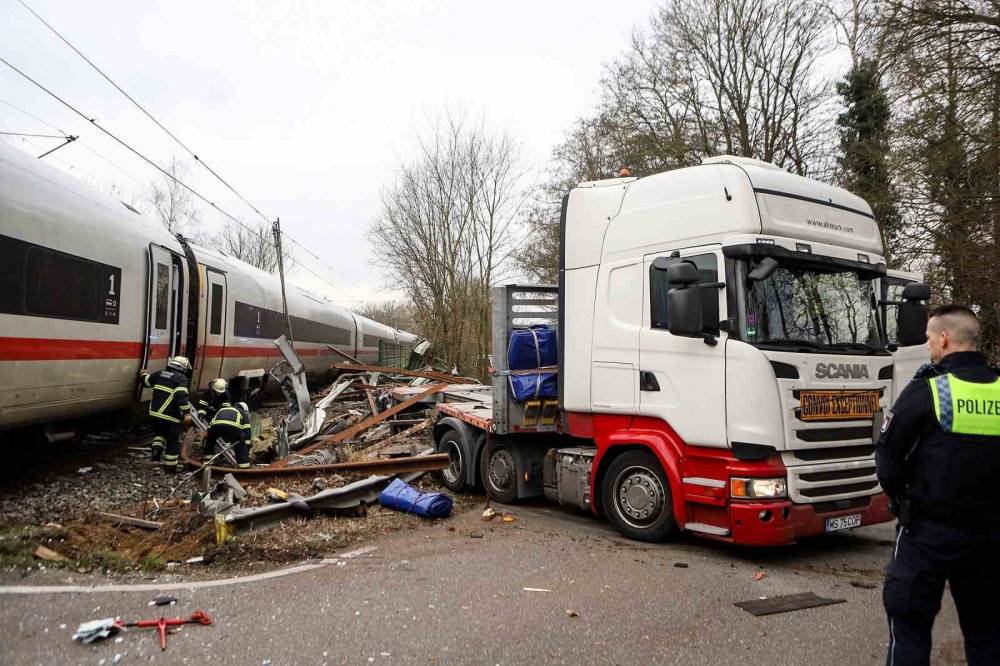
[882,520,1000,666]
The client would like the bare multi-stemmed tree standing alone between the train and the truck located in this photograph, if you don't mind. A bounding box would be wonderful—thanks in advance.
[368,115,524,376]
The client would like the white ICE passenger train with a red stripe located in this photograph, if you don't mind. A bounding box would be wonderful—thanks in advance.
[0,144,417,430]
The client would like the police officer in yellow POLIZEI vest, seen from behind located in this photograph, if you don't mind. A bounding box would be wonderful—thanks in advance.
[875,305,1000,666]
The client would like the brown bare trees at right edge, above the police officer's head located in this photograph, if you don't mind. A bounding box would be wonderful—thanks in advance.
[880,0,1000,354]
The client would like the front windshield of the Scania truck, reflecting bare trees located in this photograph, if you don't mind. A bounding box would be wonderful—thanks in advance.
[739,260,884,353]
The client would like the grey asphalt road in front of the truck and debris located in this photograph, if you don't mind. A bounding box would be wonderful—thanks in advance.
[0,505,964,666]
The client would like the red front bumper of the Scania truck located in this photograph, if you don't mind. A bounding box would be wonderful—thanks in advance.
[727,493,894,546]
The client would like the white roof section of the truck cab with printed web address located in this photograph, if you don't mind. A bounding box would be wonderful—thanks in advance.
[565,155,882,269]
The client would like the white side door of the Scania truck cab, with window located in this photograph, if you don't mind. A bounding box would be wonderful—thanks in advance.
[639,248,727,447]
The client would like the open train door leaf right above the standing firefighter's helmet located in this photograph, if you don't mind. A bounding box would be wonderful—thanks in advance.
[142,244,183,370]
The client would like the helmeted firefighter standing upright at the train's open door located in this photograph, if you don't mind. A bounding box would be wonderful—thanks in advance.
[139,356,191,471]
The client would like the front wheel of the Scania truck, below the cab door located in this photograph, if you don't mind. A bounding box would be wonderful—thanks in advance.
[601,451,677,541]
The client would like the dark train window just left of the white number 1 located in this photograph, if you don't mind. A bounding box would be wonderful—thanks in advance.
[24,247,104,321]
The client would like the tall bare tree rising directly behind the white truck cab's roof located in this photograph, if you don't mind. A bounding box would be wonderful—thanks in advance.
[518,0,835,281]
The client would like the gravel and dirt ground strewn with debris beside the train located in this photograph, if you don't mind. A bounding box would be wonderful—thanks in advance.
[0,420,482,579]
